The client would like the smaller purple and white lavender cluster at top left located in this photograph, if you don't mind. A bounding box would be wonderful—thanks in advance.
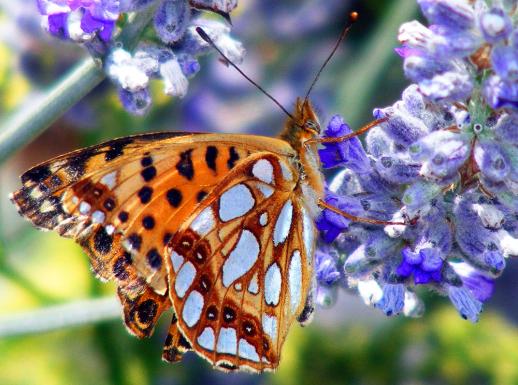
[37,0,244,115]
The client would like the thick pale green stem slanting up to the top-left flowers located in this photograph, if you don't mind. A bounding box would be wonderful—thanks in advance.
[0,6,156,164]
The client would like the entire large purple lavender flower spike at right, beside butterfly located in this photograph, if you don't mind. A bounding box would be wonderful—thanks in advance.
[317,0,518,322]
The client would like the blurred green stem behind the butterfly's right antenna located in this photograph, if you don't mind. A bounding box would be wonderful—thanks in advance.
[336,0,417,128]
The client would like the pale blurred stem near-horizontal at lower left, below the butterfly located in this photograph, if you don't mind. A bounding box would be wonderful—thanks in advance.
[0,296,121,337]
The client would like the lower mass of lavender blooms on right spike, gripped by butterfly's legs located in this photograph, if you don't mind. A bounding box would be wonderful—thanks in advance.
[317,105,518,321]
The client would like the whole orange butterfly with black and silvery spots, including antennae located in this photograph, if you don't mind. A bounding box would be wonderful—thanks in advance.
[11,13,375,372]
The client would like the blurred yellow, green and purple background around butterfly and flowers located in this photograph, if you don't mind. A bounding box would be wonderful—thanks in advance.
[0,0,518,385]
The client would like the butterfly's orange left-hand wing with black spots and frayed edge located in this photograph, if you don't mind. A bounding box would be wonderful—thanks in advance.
[11,133,316,356]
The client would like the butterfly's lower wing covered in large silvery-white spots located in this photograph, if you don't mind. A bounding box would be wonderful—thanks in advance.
[164,152,315,371]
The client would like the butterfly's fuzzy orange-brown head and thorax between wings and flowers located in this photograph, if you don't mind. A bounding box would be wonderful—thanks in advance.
[281,99,324,215]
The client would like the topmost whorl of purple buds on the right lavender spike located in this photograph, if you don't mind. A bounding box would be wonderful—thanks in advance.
[397,0,518,109]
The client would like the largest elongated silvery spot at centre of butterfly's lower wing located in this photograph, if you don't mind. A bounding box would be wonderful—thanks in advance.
[223,229,260,287]
